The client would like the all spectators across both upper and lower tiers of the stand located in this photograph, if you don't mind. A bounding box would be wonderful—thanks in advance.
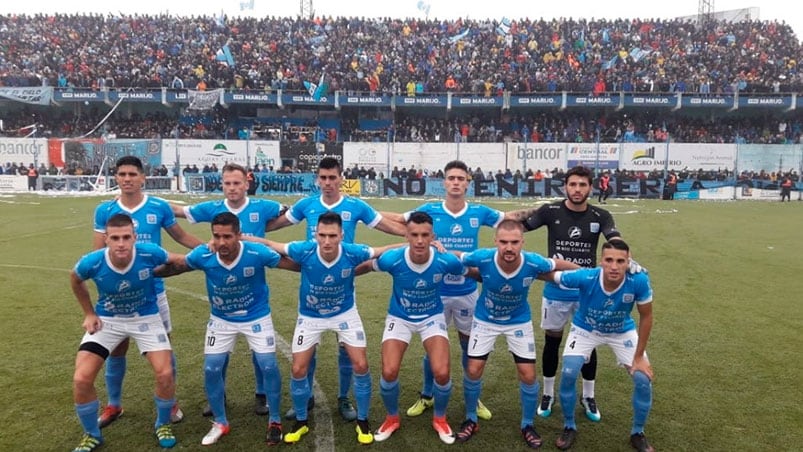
[0,14,803,144]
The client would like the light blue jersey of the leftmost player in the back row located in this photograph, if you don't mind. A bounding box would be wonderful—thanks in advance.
[93,195,176,293]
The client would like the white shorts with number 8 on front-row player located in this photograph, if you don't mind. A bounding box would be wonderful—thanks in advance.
[292,307,366,353]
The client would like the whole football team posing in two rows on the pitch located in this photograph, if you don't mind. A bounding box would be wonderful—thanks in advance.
[71,156,653,451]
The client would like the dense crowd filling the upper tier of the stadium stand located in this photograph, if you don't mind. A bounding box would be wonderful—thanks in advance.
[0,14,803,95]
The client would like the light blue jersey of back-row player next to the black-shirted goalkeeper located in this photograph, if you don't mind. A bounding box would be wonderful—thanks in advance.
[404,202,505,297]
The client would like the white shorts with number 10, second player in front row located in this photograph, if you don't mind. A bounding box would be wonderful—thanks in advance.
[204,314,276,355]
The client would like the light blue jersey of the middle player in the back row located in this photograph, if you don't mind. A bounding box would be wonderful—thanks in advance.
[285,195,382,243]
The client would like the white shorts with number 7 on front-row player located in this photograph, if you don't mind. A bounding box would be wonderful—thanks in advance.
[468,319,536,360]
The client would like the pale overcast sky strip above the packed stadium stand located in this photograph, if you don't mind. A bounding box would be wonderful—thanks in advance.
[0,0,803,39]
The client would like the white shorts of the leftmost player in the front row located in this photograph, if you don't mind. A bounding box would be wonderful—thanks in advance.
[81,314,172,353]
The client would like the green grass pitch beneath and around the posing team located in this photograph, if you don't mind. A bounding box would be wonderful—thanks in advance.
[0,195,803,451]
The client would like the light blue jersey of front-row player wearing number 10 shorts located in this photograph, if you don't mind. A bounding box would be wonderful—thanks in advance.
[187,242,281,322]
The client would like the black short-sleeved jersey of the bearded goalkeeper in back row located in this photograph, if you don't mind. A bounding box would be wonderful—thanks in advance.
[524,201,620,301]
